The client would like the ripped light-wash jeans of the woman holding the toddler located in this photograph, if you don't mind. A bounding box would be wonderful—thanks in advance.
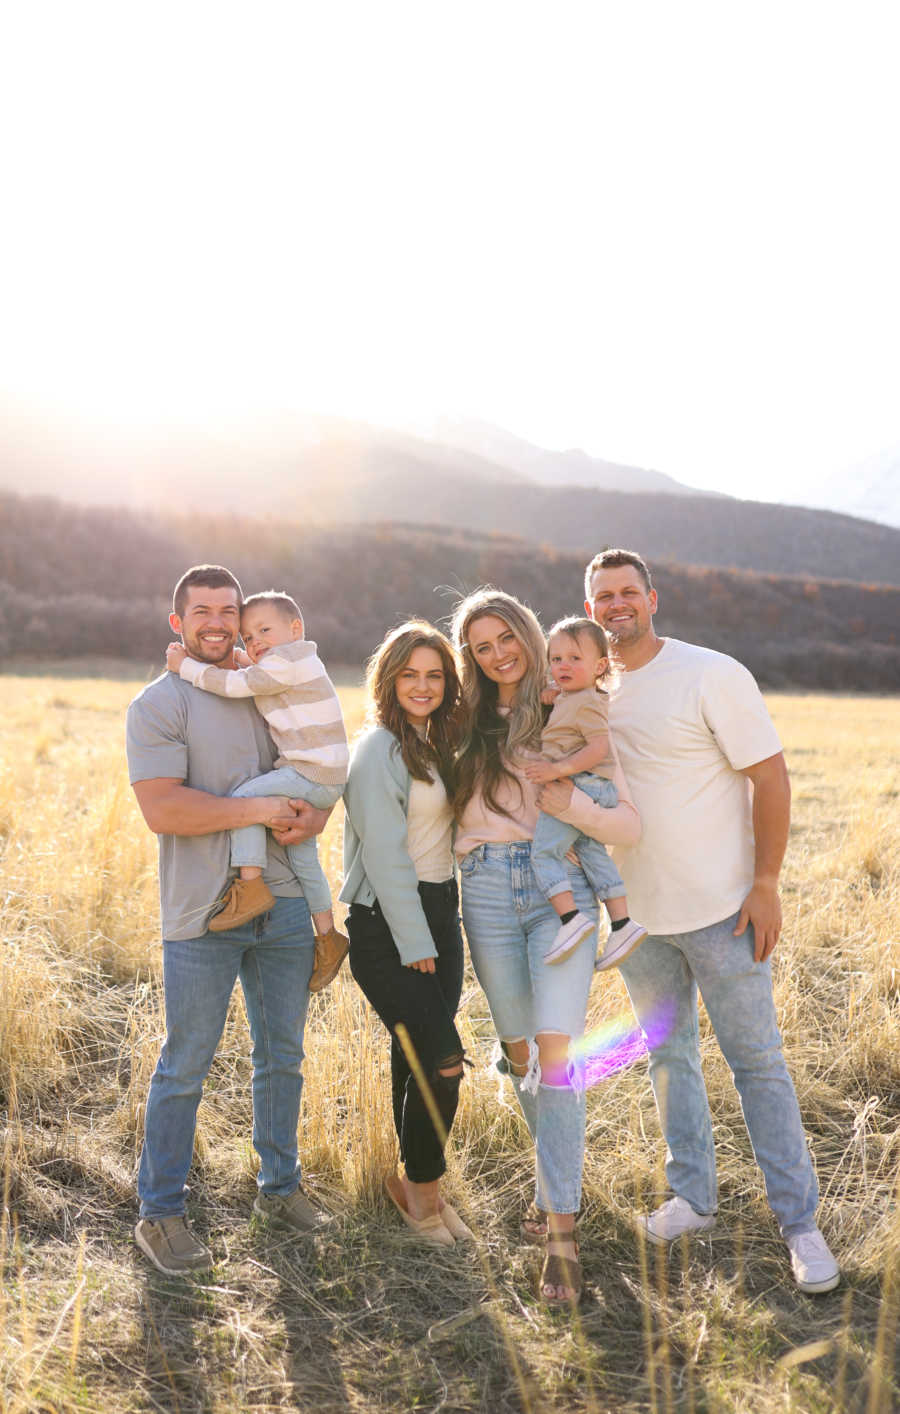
[460,840,597,1213]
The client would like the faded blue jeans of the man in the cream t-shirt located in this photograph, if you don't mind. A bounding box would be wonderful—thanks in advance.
[621,913,819,1237]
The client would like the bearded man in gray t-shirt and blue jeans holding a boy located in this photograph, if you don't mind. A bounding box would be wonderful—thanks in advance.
[126,566,333,1275]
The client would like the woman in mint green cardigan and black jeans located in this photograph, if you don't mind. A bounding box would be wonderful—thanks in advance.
[341,621,471,1246]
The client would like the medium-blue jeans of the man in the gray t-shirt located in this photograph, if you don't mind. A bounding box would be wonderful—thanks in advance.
[137,898,314,1217]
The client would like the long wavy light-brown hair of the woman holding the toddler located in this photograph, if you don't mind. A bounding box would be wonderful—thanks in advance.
[453,585,546,817]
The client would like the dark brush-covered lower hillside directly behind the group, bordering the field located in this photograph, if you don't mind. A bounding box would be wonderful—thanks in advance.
[0,495,900,691]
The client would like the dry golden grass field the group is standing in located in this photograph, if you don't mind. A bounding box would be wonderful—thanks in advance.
[0,673,900,1414]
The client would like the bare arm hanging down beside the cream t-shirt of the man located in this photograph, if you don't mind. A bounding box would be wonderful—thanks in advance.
[734,751,791,963]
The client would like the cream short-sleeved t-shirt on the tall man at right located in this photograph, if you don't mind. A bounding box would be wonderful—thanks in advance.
[610,638,781,935]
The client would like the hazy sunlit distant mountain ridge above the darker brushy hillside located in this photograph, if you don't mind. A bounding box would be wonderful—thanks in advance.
[0,419,900,584]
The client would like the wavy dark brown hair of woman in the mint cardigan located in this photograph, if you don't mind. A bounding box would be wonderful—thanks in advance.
[365,619,463,799]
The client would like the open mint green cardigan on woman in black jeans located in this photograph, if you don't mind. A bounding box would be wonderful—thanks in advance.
[340,727,437,966]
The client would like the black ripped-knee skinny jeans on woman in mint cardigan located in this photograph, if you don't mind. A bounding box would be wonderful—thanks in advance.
[347,880,463,1184]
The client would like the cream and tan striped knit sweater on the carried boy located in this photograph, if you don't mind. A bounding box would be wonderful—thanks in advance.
[180,639,350,786]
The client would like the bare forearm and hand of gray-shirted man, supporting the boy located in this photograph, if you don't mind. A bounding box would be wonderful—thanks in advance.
[133,776,302,843]
